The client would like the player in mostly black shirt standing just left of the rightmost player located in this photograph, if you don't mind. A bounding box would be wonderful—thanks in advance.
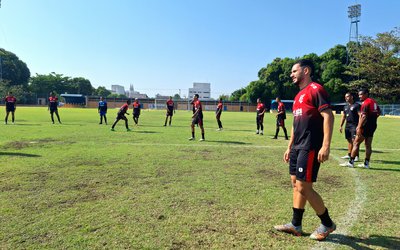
[339,92,360,160]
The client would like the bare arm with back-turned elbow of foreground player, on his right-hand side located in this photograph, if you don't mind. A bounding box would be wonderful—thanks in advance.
[318,109,335,163]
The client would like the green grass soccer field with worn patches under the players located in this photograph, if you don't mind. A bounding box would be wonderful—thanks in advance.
[0,107,400,249]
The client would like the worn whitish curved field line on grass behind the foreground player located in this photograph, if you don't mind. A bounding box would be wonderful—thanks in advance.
[312,154,367,249]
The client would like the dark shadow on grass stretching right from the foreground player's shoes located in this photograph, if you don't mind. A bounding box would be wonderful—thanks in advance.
[327,234,400,249]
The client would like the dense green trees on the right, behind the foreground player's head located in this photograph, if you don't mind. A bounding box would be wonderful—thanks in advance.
[229,28,400,103]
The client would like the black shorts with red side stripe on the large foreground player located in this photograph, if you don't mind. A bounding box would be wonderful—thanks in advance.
[289,149,320,182]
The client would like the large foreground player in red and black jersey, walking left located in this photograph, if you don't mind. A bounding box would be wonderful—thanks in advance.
[275,59,336,240]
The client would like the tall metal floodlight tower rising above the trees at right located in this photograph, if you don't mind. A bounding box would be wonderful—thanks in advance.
[347,4,361,64]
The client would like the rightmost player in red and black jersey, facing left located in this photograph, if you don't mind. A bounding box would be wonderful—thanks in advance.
[347,89,381,168]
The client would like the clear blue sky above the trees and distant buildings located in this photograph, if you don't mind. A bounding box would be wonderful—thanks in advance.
[0,0,400,98]
